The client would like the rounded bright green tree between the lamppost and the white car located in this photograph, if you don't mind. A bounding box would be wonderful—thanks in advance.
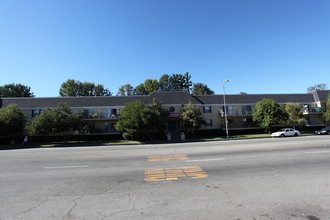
[253,99,288,132]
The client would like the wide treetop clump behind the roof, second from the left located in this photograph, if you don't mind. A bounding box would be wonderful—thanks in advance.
[59,79,112,97]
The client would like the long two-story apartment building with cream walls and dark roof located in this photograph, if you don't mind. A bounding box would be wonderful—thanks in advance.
[0,90,330,134]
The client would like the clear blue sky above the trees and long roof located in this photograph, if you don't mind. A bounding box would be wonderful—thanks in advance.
[0,0,330,97]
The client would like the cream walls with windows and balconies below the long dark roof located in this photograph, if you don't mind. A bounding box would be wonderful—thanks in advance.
[7,93,325,133]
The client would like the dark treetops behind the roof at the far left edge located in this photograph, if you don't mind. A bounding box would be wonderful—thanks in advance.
[0,83,34,97]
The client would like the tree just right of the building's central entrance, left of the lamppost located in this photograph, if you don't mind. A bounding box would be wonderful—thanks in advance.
[181,103,205,137]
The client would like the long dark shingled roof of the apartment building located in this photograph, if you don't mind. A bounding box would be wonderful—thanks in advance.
[0,90,330,108]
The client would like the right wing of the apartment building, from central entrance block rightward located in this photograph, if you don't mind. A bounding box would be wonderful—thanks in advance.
[194,90,330,129]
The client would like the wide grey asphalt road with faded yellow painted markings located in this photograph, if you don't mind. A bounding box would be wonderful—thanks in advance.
[0,136,330,220]
